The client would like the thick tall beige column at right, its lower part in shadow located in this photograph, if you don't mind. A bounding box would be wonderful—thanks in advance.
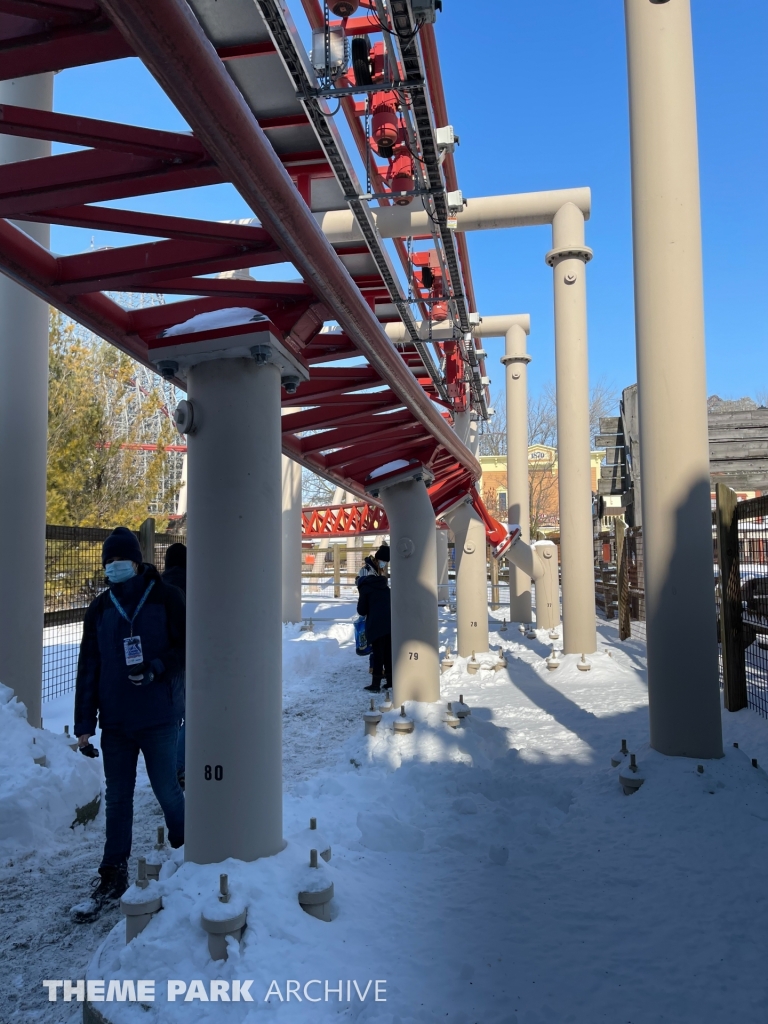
[625,0,723,758]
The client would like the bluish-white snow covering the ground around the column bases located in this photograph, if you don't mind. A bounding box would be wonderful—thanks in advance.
[0,602,768,1024]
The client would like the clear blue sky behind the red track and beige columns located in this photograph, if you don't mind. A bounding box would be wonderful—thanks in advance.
[51,0,768,407]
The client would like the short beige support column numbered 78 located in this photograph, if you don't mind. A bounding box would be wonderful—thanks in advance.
[445,502,488,657]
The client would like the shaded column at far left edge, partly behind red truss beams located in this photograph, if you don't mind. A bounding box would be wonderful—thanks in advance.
[0,74,53,726]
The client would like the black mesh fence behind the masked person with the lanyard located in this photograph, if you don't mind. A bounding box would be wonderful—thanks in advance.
[43,526,186,700]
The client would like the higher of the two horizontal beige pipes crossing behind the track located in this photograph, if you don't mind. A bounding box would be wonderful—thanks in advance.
[314,188,592,245]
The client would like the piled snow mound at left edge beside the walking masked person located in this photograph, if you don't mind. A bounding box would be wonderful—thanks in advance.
[0,683,101,855]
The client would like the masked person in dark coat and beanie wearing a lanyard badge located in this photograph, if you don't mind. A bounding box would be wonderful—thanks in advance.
[72,526,185,922]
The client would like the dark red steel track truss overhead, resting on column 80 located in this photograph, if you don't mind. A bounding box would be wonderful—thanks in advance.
[0,0,512,532]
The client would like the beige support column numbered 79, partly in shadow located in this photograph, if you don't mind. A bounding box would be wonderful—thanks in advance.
[380,480,440,705]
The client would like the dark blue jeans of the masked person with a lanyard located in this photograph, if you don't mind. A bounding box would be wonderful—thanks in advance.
[101,724,184,867]
